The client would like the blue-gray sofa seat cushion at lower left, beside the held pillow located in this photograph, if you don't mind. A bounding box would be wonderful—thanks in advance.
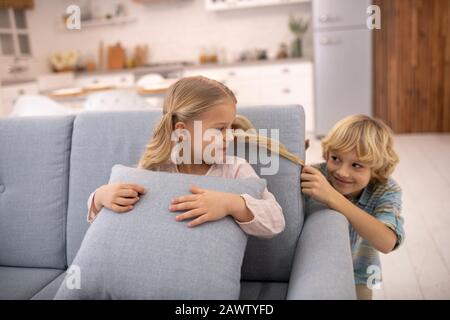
[0,266,63,300]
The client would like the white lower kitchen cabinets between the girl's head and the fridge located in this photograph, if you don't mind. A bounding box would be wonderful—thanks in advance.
[184,61,314,132]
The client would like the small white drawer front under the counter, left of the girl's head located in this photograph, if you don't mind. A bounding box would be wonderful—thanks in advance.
[75,72,134,88]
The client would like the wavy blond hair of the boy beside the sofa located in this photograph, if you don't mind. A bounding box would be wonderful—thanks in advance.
[322,115,399,182]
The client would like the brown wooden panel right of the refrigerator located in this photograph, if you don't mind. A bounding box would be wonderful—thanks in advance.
[374,0,450,133]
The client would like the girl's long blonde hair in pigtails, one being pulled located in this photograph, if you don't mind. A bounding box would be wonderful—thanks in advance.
[137,76,303,170]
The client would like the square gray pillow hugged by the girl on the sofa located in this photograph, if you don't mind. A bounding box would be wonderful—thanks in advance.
[55,165,266,299]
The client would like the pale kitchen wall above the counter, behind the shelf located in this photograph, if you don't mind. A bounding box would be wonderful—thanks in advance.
[0,0,312,74]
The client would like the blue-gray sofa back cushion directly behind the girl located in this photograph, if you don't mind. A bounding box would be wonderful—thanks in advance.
[67,106,305,281]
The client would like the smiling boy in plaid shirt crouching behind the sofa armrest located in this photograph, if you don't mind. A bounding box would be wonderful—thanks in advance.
[301,115,405,300]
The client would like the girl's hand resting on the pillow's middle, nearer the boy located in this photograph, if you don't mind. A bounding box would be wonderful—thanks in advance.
[169,185,253,227]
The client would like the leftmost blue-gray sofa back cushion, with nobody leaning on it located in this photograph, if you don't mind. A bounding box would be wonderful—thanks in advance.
[0,116,74,269]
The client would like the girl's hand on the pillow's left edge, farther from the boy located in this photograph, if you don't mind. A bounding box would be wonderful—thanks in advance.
[94,183,147,213]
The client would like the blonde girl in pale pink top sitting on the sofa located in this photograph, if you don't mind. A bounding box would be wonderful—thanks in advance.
[88,76,303,238]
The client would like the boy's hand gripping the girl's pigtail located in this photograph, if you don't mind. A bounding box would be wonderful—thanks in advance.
[301,166,340,206]
